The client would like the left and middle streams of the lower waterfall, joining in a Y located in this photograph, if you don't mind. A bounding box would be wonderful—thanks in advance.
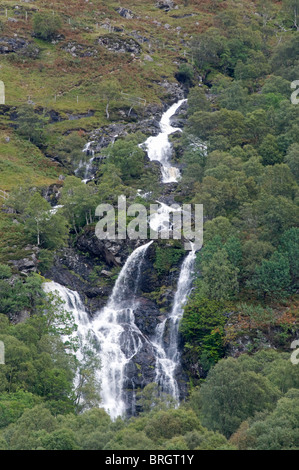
[44,241,153,419]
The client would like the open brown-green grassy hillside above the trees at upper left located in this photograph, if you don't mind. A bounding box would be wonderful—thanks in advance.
[0,0,218,262]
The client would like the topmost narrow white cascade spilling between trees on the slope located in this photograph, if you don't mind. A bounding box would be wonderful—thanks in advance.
[141,99,187,183]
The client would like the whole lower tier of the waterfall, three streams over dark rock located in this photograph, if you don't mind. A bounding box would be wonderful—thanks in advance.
[44,241,195,419]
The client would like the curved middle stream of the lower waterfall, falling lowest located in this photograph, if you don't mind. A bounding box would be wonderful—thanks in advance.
[93,241,152,418]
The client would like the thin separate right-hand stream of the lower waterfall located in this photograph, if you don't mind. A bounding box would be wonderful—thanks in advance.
[153,250,196,403]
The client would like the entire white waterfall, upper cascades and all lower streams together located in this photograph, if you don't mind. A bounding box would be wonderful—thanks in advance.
[45,100,196,419]
